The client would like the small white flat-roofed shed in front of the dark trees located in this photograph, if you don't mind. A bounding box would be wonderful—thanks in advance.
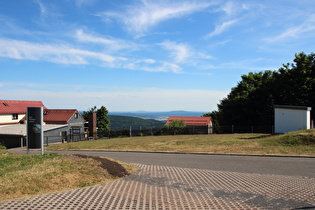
[274,105,312,133]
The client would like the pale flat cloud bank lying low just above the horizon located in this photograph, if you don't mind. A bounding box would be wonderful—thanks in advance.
[1,88,228,112]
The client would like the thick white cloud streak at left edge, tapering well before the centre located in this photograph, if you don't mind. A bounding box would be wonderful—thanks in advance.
[0,39,120,64]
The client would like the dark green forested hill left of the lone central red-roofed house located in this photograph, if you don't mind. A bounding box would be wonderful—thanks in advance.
[108,115,165,130]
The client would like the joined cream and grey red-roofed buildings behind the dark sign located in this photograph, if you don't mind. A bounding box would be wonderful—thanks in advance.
[0,100,86,147]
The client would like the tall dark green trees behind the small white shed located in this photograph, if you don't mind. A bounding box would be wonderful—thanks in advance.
[204,52,315,130]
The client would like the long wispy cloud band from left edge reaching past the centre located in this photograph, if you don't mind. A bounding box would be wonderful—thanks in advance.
[0,39,182,73]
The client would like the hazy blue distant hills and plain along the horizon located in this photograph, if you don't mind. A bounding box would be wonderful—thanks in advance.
[109,111,207,122]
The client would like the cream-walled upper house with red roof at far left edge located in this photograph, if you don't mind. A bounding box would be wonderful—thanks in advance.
[0,100,46,125]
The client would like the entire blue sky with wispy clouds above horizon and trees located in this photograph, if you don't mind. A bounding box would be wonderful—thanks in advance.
[0,0,315,112]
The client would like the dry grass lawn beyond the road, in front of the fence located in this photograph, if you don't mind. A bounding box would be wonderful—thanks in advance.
[46,131,315,156]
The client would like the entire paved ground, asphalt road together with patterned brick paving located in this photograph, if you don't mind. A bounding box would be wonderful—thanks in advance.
[6,149,315,209]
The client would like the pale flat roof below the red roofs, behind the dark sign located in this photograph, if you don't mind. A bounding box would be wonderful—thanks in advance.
[0,124,67,136]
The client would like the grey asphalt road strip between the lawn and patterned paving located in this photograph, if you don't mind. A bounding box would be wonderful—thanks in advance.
[51,150,315,178]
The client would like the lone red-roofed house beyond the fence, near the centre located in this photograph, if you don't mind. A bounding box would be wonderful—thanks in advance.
[166,116,213,134]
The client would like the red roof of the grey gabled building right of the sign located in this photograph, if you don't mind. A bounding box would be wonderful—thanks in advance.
[44,109,82,124]
